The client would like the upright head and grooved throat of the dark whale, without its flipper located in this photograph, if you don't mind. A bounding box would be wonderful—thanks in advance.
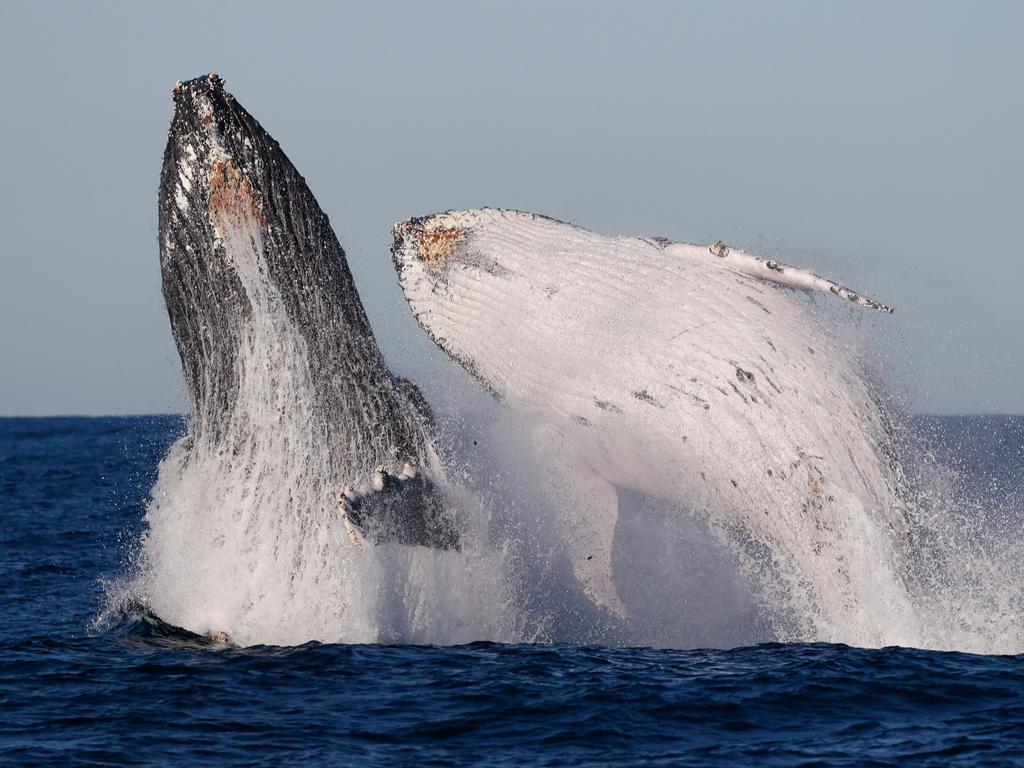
[158,75,399,450]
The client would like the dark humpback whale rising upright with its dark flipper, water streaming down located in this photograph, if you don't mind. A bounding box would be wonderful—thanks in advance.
[159,74,459,549]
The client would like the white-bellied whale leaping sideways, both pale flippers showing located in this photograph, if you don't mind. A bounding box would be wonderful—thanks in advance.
[392,209,905,642]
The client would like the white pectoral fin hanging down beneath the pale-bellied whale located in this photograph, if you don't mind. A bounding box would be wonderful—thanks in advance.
[535,423,627,618]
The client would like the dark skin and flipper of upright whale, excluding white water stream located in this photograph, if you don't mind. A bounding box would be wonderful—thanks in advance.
[158,75,458,548]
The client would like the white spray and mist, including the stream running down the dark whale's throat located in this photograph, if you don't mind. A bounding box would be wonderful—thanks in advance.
[123,163,1024,652]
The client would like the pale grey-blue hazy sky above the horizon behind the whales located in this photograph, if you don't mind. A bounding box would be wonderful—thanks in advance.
[0,0,1024,415]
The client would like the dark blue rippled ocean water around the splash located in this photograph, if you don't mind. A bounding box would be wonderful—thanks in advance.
[0,417,1024,766]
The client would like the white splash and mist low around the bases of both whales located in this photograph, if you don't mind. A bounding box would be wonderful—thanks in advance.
[116,346,1024,653]
